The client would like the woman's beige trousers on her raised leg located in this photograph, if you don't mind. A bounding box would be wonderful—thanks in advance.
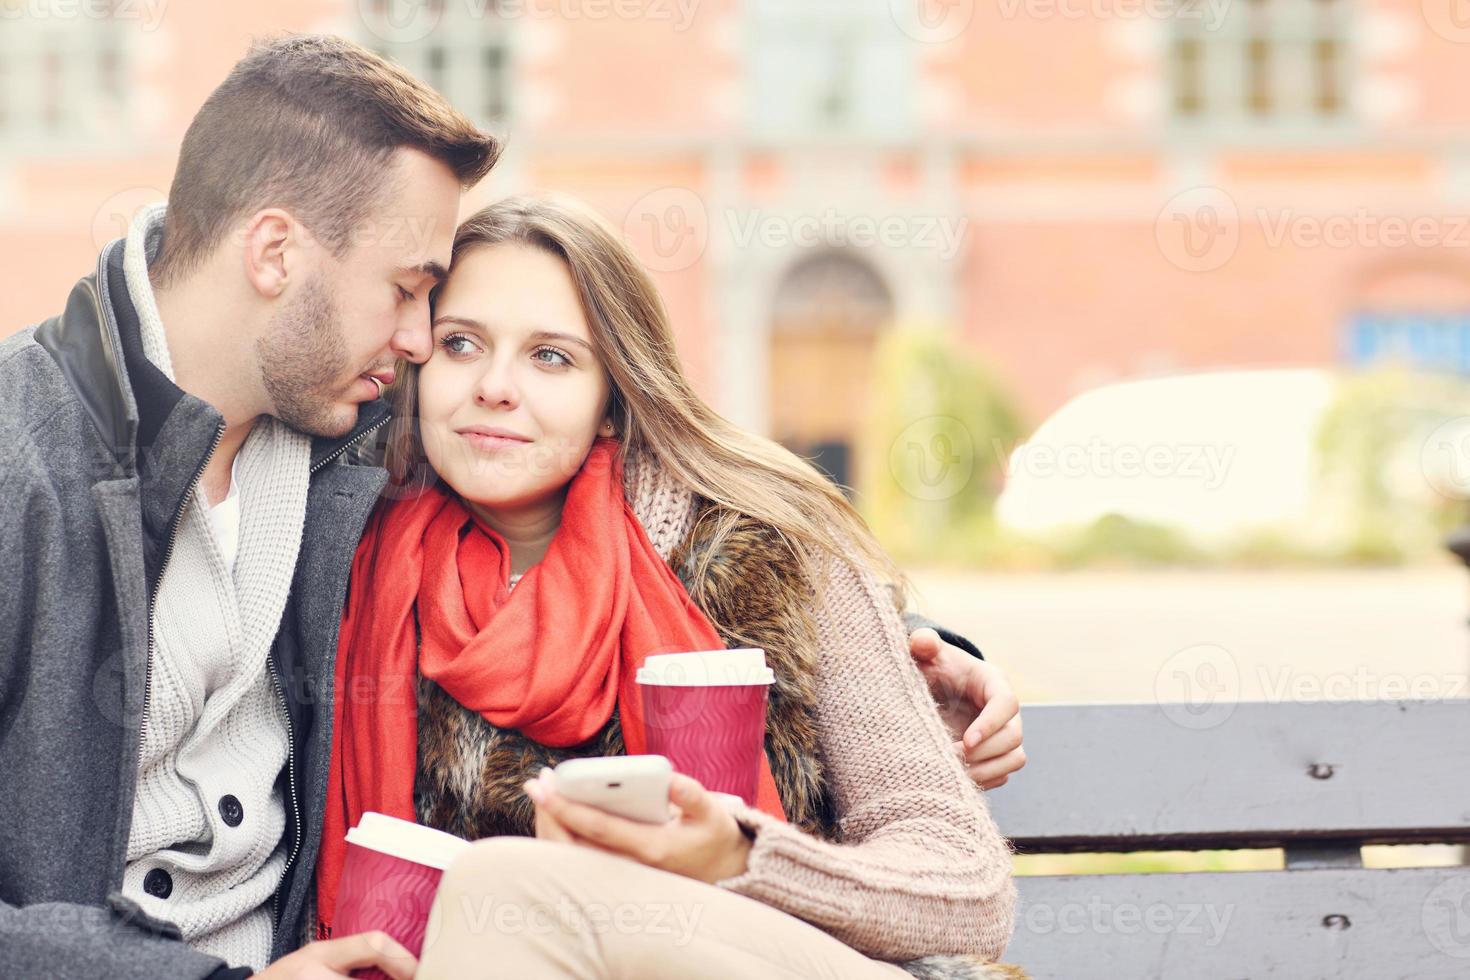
[417,837,908,980]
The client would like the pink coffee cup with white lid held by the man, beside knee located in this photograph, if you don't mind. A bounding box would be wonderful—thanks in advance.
[332,813,469,980]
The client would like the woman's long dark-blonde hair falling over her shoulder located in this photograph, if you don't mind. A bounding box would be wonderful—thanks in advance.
[387,195,904,605]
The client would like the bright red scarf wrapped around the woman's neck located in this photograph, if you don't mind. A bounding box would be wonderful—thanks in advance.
[316,439,785,937]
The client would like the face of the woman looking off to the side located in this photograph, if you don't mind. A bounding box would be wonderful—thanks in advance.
[419,244,609,508]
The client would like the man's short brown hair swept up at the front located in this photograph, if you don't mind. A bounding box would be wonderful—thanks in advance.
[153,34,500,284]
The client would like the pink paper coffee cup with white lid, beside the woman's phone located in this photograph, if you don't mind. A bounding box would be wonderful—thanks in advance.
[638,649,775,805]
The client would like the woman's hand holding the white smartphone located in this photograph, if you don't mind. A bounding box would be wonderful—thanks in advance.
[525,768,751,884]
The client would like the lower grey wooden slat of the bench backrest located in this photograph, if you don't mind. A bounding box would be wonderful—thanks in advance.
[1004,868,1470,980]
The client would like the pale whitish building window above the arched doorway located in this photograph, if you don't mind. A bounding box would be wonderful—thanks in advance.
[745,0,917,137]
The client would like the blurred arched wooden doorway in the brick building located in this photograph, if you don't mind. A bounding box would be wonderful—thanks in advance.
[770,251,894,486]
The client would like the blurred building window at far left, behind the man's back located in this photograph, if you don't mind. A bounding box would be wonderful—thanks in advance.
[0,7,132,153]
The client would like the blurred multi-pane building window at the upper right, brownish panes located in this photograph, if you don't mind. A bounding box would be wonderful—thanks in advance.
[1169,0,1351,129]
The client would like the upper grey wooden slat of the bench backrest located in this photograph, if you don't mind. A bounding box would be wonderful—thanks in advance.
[988,701,1470,852]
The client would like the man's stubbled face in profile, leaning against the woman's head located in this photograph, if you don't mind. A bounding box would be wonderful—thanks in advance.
[257,148,460,436]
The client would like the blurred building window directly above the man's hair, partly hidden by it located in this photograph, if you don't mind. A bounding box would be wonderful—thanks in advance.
[360,0,512,126]
